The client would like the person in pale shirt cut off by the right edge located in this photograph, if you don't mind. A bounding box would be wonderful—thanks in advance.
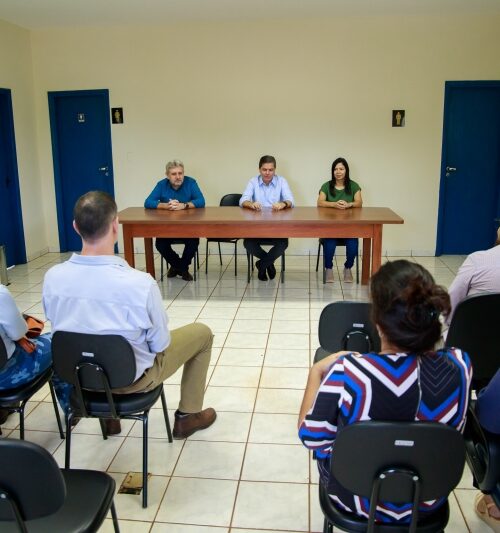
[447,228,500,323]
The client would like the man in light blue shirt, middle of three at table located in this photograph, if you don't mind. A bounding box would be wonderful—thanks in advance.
[240,155,294,281]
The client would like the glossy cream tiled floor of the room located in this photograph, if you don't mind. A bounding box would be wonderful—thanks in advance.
[3,254,490,533]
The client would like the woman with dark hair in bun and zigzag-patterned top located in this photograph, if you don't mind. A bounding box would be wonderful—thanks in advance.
[299,260,472,522]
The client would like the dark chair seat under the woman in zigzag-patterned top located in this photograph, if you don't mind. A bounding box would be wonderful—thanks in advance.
[319,483,450,533]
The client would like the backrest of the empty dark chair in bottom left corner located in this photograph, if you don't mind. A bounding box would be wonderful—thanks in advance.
[0,439,66,520]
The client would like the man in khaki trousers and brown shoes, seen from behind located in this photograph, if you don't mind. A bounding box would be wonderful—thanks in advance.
[43,191,216,439]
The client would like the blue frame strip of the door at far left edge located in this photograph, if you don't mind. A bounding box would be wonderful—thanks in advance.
[0,88,26,264]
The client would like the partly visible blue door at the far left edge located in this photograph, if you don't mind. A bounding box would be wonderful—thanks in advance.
[0,89,26,266]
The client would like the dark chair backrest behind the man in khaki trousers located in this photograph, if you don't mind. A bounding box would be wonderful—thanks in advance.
[52,331,136,390]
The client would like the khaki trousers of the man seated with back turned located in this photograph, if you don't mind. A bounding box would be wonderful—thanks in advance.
[113,322,214,413]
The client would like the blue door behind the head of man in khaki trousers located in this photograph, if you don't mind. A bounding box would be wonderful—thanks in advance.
[49,89,114,252]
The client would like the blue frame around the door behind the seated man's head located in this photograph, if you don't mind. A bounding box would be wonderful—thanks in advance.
[47,89,114,251]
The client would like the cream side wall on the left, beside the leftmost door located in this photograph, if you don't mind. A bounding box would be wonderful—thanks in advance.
[0,20,48,259]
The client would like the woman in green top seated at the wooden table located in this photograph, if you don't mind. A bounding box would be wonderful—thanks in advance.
[317,157,363,283]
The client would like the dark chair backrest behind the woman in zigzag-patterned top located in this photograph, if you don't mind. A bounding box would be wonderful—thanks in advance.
[331,421,465,503]
